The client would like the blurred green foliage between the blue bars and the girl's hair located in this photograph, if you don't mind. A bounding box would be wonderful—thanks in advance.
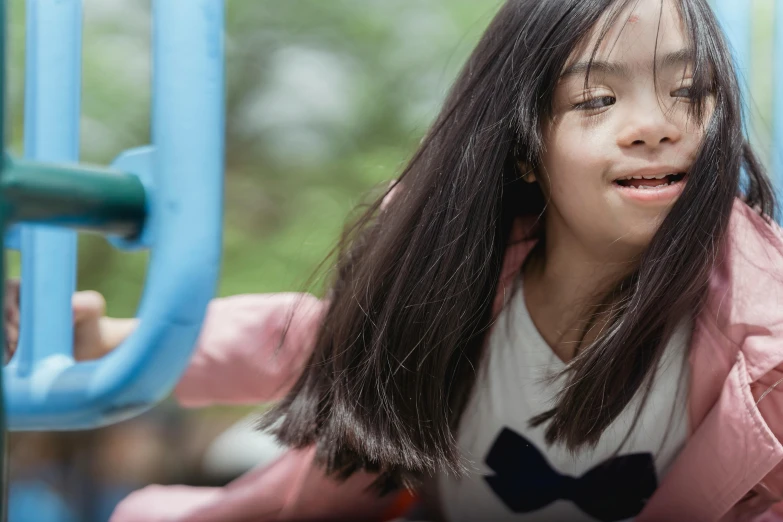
[9,0,500,316]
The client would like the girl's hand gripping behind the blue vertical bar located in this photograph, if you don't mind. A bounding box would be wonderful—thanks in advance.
[3,280,137,362]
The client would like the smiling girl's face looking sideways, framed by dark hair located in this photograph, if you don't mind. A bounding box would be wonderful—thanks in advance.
[537,0,713,259]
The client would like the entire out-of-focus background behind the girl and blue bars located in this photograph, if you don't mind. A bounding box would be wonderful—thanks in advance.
[0,0,775,522]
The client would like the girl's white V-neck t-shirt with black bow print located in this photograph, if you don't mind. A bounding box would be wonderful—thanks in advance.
[437,285,691,522]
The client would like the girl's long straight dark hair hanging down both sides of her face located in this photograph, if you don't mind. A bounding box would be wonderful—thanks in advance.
[262,0,774,486]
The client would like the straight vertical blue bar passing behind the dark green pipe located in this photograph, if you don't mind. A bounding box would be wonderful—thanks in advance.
[13,0,82,376]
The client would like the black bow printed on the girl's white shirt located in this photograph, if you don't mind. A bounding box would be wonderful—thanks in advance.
[484,428,658,522]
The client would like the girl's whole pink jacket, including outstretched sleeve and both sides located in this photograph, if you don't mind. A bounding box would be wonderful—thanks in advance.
[111,197,783,522]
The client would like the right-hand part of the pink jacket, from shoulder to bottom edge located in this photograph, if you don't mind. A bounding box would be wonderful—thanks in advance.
[637,200,783,521]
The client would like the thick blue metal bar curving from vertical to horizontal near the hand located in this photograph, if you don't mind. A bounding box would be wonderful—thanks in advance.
[3,0,225,431]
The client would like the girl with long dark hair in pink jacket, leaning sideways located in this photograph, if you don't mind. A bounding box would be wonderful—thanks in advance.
[10,0,783,522]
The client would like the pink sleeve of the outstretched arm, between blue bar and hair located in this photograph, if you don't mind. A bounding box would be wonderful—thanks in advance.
[174,293,326,407]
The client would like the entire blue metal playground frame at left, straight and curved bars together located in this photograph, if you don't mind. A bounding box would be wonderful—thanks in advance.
[3,0,224,430]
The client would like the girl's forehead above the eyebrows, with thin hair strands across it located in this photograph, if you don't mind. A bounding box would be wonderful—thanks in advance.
[569,0,690,65]
